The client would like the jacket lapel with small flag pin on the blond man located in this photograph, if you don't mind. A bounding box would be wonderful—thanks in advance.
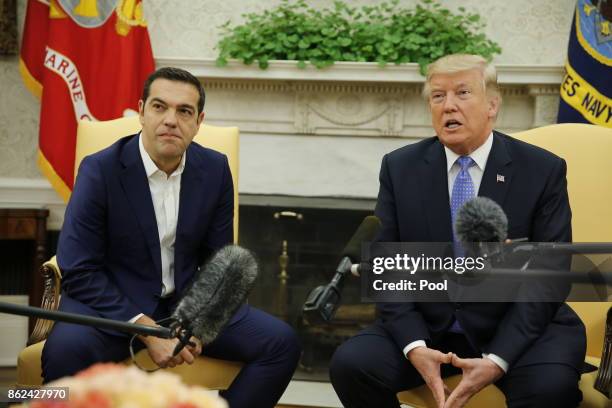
[478,131,514,206]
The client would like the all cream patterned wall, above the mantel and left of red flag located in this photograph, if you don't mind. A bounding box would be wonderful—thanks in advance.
[0,0,575,178]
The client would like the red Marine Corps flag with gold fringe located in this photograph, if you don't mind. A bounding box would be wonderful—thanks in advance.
[20,0,154,200]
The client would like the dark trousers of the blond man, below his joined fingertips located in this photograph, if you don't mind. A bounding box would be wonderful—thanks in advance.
[330,326,582,408]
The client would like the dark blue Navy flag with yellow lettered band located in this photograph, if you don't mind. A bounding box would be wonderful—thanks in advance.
[557,0,612,128]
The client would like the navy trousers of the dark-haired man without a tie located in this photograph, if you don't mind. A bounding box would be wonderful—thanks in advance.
[42,297,301,408]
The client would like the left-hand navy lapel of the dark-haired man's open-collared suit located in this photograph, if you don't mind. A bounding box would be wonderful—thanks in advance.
[120,136,161,277]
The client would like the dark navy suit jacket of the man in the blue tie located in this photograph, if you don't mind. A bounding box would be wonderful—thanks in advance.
[376,132,586,369]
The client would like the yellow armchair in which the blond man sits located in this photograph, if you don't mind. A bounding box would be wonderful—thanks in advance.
[398,124,612,408]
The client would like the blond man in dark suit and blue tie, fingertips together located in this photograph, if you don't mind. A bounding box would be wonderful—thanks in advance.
[330,54,586,408]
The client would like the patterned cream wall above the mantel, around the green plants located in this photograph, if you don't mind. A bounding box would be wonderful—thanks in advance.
[145,0,576,65]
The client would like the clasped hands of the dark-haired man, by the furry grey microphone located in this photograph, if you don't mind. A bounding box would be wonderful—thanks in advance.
[136,316,202,368]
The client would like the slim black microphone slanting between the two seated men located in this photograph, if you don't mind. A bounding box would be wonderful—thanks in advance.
[302,215,380,324]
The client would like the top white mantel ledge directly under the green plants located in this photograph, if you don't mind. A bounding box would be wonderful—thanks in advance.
[155,57,564,85]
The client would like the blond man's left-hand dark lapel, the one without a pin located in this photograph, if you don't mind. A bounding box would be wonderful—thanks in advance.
[419,140,453,242]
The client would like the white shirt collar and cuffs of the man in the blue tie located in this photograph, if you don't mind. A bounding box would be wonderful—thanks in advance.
[403,132,508,372]
